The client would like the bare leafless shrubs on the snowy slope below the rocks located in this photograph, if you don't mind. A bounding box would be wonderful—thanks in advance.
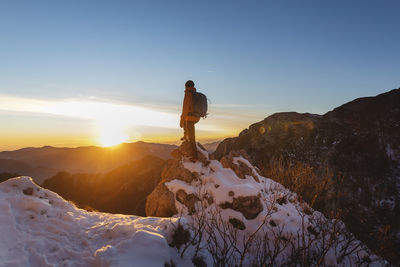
[168,185,378,266]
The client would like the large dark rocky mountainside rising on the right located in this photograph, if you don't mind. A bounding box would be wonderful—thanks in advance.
[213,88,400,262]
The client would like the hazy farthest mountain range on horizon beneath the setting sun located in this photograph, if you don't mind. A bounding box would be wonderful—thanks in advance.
[0,141,177,184]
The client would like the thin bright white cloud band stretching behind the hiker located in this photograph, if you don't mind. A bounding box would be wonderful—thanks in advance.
[0,95,263,135]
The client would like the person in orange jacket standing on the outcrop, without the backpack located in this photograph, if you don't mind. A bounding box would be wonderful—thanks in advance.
[180,80,200,162]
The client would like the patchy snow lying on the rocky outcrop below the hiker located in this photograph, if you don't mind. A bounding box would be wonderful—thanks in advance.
[165,148,379,266]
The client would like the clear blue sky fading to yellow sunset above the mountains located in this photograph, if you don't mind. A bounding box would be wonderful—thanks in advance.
[0,0,400,150]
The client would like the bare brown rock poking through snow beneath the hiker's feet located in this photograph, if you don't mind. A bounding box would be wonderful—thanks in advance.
[146,142,263,222]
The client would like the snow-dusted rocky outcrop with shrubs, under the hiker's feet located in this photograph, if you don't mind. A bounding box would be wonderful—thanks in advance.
[147,145,382,266]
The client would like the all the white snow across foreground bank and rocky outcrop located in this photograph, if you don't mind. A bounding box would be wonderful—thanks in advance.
[0,148,384,267]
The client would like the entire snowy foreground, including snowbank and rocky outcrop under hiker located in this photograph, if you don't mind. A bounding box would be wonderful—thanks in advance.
[0,144,381,266]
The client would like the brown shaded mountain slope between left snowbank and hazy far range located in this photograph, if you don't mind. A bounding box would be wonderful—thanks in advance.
[42,155,165,216]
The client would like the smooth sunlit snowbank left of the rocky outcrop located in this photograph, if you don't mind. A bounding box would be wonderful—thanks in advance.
[0,177,179,266]
